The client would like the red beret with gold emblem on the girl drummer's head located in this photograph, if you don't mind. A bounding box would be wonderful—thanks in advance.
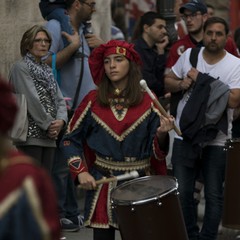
[89,40,142,85]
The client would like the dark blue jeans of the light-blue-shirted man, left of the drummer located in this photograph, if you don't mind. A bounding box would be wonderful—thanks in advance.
[52,148,80,218]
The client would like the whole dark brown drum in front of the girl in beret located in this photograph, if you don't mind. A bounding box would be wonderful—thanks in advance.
[111,176,188,240]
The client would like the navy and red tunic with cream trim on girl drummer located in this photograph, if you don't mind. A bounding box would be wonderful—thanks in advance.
[61,90,168,228]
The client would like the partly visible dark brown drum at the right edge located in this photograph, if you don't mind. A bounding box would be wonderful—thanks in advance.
[222,139,240,229]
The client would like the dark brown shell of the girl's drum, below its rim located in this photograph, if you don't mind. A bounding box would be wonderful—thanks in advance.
[111,174,188,240]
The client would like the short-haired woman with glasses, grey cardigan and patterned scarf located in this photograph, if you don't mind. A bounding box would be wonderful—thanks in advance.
[10,25,67,173]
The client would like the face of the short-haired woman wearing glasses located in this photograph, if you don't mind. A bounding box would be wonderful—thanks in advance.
[29,32,51,61]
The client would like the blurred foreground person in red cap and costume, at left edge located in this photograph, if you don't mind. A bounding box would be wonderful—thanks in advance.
[0,77,60,240]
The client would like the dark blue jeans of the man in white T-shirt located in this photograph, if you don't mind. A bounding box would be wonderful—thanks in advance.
[172,140,226,240]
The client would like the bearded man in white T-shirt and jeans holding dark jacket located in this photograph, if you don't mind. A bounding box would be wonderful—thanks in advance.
[165,15,240,240]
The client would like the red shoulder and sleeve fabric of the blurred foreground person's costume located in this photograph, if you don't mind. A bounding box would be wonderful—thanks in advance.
[0,157,61,240]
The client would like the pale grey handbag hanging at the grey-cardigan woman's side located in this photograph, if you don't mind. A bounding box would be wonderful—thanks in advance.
[9,93,28,142]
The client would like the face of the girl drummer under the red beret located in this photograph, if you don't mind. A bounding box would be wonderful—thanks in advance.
[104,54,129,89]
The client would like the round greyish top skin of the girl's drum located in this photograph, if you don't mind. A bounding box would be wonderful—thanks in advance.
[111,175,177,205]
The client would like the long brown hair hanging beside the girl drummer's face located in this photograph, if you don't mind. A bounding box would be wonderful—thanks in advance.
[97,61,143,106]
